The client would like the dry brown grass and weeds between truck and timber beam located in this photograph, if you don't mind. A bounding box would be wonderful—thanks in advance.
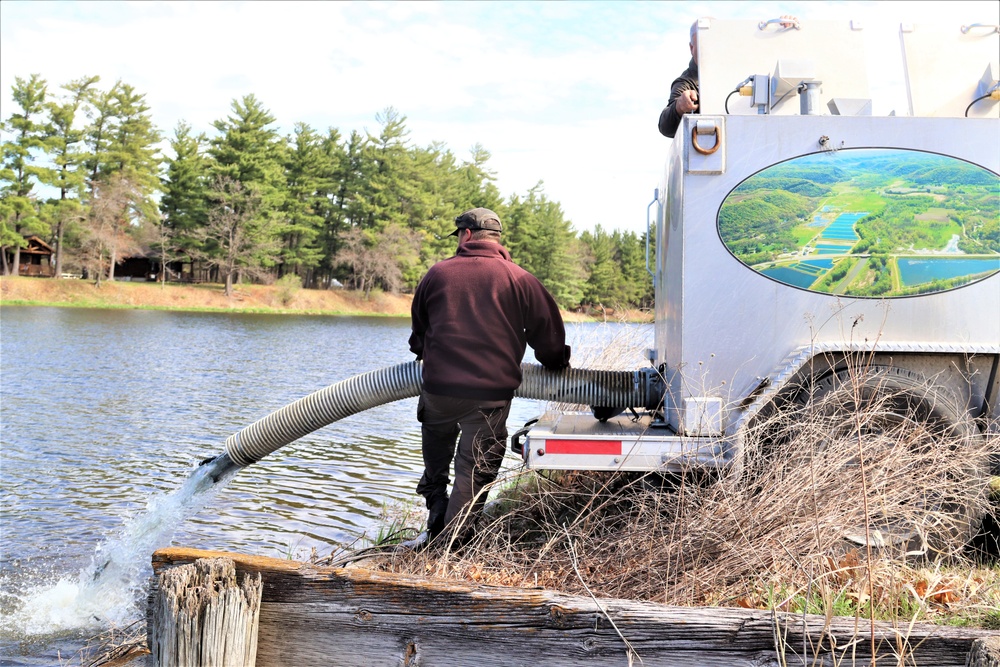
[370,334,1000,625]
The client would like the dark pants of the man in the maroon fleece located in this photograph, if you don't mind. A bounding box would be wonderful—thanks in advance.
[417,392,510,537]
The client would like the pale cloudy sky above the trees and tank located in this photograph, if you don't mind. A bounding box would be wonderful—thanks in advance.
[0,0,1000,232]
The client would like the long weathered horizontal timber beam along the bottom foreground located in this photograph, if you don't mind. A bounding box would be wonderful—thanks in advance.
[153,549,991,667]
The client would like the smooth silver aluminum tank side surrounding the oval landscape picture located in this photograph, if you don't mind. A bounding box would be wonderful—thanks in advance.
[655,116,1000,432]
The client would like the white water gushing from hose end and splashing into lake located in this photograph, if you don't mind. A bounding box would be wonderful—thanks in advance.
[0,454,239,637]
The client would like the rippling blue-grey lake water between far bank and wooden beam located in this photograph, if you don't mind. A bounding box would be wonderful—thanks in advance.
[0,307,652,665]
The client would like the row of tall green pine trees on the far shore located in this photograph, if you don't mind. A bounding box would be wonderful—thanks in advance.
[0,74,652,308]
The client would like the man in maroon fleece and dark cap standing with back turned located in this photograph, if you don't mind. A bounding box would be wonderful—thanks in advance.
[410,208,570,538]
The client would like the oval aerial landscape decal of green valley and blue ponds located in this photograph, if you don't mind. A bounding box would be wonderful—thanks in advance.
[718,148,1000,298]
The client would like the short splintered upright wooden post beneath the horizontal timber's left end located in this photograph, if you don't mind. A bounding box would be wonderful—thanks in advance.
[148,558,263,667]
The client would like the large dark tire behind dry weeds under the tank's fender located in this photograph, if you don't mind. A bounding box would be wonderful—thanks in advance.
[775,366,988,556]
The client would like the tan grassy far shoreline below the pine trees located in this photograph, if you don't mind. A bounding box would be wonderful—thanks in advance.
[0,276,652,323]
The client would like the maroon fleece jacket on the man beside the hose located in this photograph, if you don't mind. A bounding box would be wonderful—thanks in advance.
[410,241,570,400]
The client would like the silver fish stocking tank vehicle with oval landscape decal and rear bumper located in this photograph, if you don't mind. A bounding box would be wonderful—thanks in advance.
[512,19,1000,549]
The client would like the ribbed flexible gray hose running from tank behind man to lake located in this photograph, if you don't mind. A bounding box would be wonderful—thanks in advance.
[226,361,646,466]
